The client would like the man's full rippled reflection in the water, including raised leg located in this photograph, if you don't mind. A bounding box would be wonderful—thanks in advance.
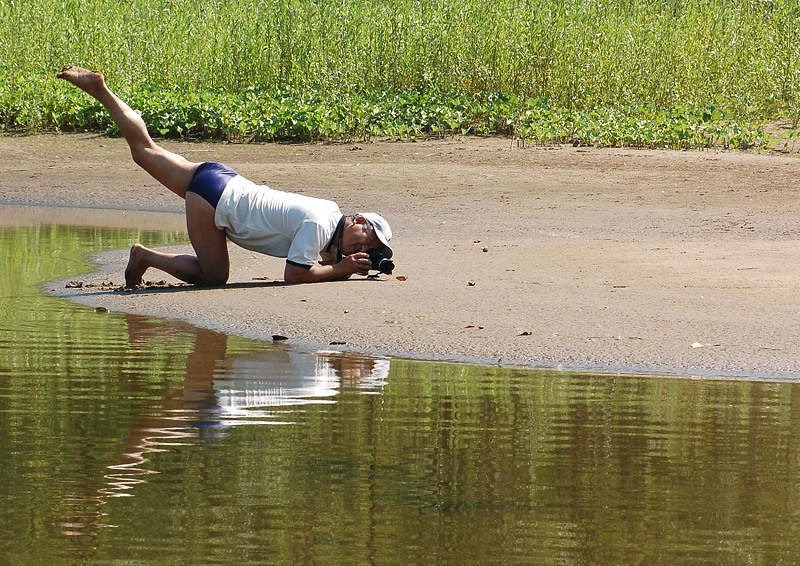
[61,315,390,536]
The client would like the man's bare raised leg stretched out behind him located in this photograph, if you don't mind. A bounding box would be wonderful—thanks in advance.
[56,67,199,198]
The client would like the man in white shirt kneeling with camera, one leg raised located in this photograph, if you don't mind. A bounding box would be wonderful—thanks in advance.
[56,67,393,287]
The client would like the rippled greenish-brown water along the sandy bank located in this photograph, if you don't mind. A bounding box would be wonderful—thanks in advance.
[0,219,800,564]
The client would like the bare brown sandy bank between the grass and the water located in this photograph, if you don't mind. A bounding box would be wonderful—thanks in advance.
[0,134,800,378]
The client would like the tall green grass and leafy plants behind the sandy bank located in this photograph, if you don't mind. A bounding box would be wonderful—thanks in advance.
[0,0,800,148]
